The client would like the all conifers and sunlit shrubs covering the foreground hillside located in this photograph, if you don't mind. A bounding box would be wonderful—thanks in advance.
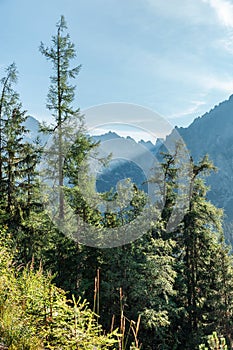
[0,16,233,350]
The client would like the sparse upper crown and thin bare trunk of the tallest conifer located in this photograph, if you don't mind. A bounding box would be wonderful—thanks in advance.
[40,16,81,220]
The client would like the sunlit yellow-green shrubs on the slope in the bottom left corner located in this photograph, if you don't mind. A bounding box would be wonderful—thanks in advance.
[0,228,117,350]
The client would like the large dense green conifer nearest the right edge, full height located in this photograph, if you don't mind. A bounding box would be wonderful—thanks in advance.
[164,157,233,349]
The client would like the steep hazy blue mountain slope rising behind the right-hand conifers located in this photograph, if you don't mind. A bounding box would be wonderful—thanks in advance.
[176,95,233,221]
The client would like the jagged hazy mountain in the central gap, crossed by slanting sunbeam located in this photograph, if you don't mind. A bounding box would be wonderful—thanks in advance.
[93,131,161,192]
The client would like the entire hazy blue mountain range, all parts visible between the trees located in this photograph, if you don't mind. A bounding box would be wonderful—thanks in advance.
[26,95,233,227]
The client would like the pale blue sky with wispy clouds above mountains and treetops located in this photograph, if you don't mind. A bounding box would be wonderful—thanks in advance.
[0,0,233,141]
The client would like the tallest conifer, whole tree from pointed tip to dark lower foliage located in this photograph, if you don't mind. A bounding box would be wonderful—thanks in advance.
[40,16,102,293]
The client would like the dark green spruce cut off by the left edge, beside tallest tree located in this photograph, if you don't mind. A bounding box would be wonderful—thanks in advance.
[0,64,41,263]
